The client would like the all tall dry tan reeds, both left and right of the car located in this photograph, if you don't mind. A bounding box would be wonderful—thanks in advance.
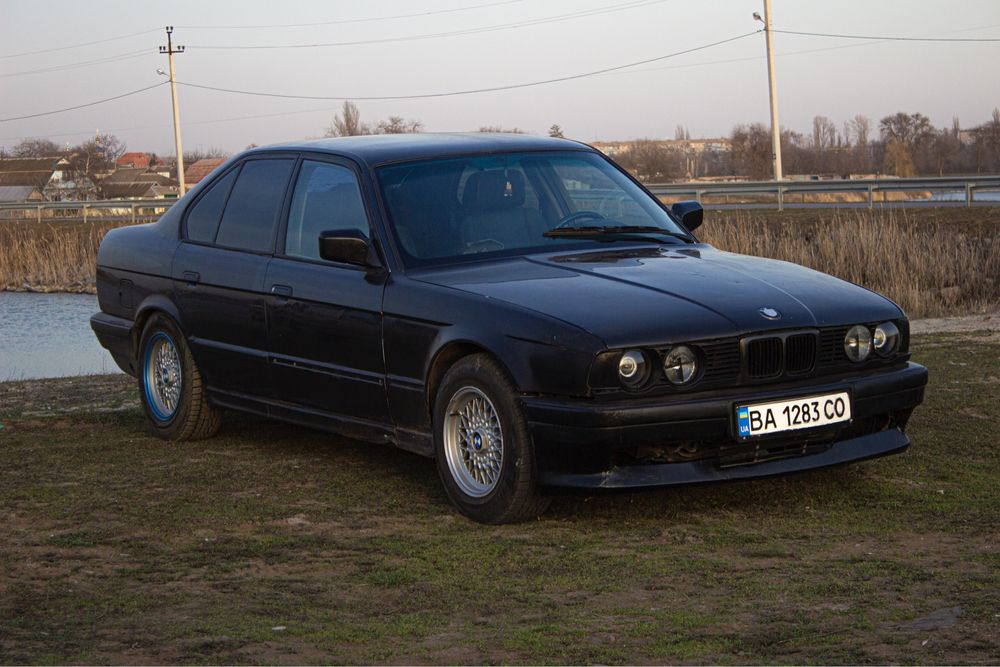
[0,210,1000,317]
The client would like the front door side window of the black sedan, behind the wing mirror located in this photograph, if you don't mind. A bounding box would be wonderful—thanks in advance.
[285,160,369,259]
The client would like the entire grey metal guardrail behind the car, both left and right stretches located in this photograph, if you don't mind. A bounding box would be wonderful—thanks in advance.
[0,176,1000,224]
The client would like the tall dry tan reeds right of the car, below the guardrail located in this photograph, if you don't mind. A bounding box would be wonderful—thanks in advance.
[699,210,1000,317]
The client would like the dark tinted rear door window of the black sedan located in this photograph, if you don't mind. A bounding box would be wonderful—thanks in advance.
[215,159,295,252]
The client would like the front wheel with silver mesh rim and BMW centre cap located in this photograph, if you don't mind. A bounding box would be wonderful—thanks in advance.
[434,354,550,524]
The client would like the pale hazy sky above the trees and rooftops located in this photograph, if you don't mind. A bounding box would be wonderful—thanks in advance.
[0,0,1000,155]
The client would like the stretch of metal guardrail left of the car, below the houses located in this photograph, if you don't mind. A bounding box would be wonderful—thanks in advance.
[0,199,177,224]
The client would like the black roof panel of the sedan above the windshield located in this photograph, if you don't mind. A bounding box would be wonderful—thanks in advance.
[248,132,594,167]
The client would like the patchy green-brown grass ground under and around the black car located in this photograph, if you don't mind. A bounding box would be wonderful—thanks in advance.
[0,333,1000,664]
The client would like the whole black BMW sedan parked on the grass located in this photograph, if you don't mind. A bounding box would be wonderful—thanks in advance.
[91,134,927,523]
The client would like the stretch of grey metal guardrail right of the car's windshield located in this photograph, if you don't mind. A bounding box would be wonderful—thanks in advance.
[646,176,1000,211]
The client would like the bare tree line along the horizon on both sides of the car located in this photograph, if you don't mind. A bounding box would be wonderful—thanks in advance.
[7,101,1000,181]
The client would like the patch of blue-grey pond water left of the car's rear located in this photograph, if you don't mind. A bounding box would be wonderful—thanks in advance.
[0,292,121,381]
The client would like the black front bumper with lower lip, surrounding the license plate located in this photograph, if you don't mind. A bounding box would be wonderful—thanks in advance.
[522,363,927,488]
